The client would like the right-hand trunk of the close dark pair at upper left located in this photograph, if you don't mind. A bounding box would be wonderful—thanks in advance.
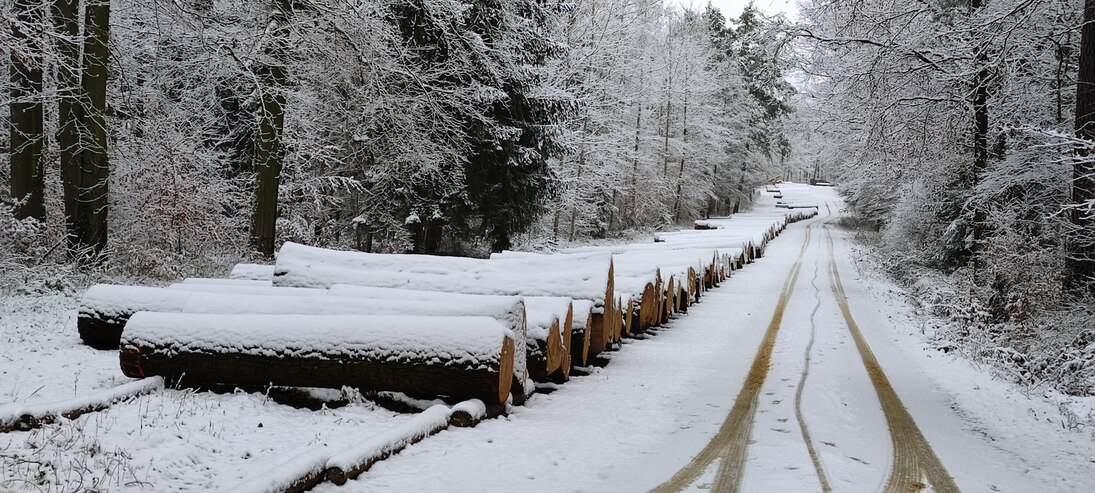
[74,0,111,252]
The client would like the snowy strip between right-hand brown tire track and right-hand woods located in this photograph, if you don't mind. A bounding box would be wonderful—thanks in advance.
[833,229,1095,492]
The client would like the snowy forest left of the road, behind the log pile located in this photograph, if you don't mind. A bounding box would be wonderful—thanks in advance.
[0,0,792,277]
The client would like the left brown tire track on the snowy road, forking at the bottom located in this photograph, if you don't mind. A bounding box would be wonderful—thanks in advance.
[650,208,831,493]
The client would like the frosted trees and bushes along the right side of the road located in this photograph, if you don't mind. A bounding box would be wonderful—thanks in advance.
[795,0,1095,394]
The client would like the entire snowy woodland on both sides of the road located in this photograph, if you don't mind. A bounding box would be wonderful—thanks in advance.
[6,0,1095,394]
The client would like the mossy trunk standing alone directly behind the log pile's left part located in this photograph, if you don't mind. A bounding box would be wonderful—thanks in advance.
[251,0,292,257]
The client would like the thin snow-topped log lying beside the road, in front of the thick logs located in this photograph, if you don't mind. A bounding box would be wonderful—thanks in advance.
[326,405,451,485]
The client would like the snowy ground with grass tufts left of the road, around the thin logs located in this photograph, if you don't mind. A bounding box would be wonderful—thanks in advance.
[0,295,431,492]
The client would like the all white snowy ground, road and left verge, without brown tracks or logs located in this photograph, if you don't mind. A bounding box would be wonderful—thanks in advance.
[0,185,1095,492]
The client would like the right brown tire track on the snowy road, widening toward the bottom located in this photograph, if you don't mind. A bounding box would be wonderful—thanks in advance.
[822,223,961,493]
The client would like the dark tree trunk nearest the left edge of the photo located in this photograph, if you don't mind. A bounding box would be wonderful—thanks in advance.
[9,0,46,221]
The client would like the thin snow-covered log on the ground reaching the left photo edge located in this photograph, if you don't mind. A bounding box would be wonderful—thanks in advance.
[0,377,163,433]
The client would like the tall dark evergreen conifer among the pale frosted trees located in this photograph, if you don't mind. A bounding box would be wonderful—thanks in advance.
[464,0,567,251]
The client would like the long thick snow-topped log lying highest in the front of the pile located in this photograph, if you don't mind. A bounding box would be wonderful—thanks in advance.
[274,242,620,354]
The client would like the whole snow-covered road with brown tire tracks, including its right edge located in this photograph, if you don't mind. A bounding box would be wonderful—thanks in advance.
[335,188,1095,492]
